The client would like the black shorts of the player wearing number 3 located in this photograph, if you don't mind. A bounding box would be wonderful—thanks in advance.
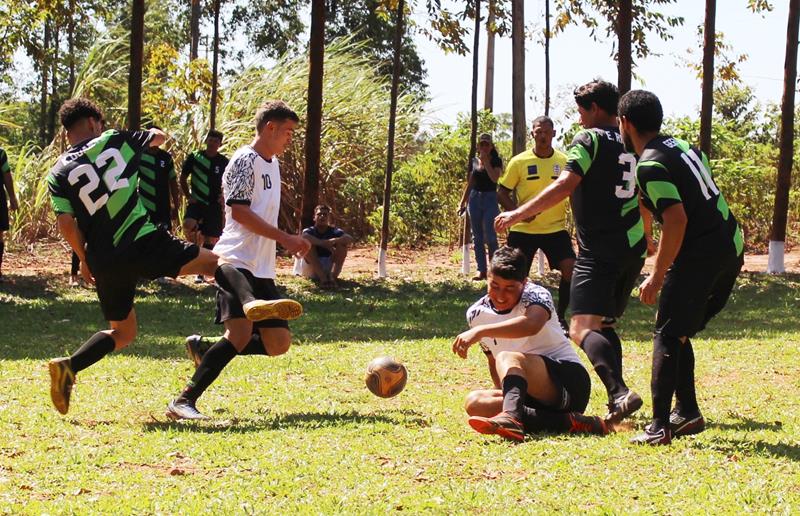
[569,251,644,318]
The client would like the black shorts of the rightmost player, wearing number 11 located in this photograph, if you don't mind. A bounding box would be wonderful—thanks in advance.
[656,254,744,337]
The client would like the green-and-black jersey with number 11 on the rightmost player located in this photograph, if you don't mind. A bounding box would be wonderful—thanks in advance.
[636,136,744,261]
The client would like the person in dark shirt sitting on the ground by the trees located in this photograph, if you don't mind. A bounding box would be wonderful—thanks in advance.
[303,204,353,288]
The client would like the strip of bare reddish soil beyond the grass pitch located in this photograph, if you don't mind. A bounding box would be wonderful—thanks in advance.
[3,241,800,282]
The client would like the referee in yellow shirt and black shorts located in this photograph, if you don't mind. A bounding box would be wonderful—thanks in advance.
[497,116,575,328]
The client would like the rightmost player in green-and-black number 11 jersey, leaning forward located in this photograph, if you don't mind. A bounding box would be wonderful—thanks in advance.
[619,90,744,444]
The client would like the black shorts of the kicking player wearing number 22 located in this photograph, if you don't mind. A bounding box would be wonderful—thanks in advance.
[86,229,200,321]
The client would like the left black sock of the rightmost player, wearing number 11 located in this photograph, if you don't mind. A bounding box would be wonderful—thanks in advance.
[650,333,681,428]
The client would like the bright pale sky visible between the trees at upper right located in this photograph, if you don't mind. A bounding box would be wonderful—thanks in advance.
[413,0,788,130]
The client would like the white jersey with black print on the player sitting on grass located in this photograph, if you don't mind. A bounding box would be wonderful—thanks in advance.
[467,281,581,364]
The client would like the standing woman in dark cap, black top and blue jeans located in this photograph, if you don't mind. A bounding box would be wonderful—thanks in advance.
[459,133,503,281]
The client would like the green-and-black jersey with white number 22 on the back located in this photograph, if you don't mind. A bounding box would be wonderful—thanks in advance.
[47,130,156,261]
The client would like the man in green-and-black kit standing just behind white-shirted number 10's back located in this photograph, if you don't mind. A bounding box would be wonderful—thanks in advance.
[180,130,228,283]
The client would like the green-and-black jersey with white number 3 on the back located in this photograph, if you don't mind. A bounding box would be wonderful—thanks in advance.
[567,127,647,260]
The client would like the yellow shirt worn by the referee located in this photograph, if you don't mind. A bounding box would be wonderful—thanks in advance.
[497,149,569,235]
